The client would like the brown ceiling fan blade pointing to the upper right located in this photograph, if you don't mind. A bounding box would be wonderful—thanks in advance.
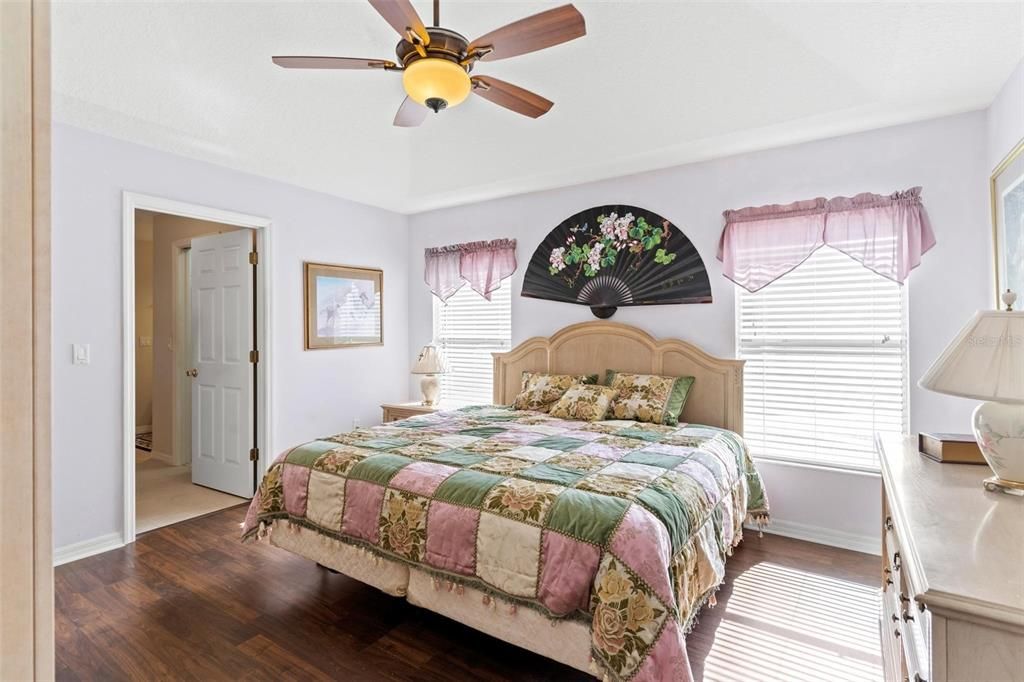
[468,5,587,61]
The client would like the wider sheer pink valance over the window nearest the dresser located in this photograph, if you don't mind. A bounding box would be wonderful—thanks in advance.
[718,187,935,292]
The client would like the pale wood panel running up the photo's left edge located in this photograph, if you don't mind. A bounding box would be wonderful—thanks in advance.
[0,0,54,679]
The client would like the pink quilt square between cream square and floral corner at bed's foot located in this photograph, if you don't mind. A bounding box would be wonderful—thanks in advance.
[537,530,601,615]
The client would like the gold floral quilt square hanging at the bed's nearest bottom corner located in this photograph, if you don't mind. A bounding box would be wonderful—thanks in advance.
[591,553,670,679]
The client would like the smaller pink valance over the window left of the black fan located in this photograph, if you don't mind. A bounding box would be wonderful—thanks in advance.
[423,240,516,301]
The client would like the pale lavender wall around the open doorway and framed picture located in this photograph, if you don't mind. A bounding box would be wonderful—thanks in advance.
[52,125,411,548]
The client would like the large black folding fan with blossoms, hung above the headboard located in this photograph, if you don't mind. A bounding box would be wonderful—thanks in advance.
[522,206,712,319]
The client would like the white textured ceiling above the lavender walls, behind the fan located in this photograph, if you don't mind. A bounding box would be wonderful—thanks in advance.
[53,0,1024,212]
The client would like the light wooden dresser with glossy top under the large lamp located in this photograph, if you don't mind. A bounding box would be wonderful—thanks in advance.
[877,436,1024,682]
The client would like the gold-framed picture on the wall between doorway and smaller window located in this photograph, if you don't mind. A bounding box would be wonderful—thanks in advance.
[304,263,384,350]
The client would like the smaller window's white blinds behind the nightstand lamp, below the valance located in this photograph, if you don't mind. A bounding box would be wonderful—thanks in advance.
[434,282,512,404]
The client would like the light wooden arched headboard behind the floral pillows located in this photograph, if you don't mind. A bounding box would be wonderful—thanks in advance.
[494,322,743,434]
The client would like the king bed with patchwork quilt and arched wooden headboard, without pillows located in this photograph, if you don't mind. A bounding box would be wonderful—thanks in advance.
[243,322,768,682]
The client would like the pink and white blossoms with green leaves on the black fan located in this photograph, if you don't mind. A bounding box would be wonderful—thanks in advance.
[548,213,676,287]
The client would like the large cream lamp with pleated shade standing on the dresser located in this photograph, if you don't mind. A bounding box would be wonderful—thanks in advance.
[920,303,1024,489]
